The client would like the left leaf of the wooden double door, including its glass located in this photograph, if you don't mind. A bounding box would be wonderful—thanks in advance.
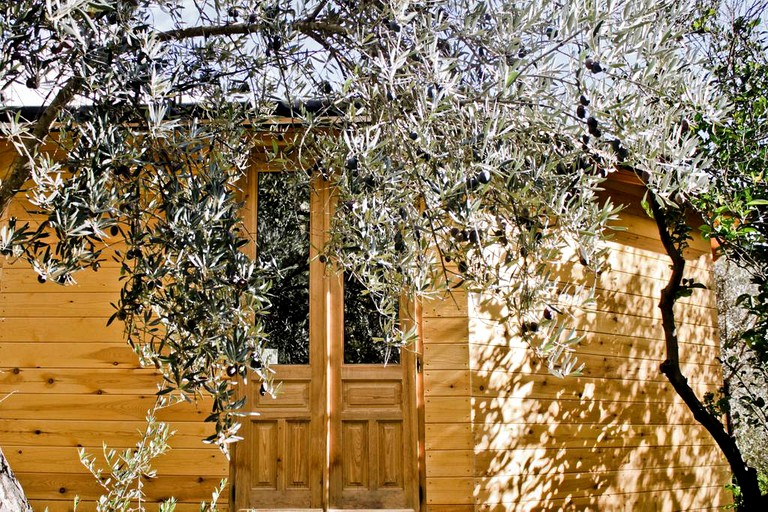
[232,172,327,510]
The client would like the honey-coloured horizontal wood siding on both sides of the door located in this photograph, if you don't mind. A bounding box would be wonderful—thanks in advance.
[0,144,729,512]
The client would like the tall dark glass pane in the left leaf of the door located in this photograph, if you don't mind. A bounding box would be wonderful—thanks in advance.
[256,172,309,364]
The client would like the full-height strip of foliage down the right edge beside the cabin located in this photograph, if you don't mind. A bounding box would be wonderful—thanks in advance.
[694,1,768,501]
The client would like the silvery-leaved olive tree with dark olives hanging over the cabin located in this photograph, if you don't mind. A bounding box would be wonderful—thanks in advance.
[0,0,739,508]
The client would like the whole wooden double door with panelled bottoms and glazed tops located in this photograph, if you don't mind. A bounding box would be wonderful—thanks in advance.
[233,175,418,510]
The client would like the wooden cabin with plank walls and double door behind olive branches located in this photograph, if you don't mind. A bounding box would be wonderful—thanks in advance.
[0,138,730,512]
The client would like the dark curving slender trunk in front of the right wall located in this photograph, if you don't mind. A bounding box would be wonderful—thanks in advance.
[650,192,768,510]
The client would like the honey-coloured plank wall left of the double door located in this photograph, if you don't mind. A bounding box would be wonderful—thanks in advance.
[0,189,229,512]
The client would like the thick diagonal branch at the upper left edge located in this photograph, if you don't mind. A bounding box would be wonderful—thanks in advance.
[0,77,83,216]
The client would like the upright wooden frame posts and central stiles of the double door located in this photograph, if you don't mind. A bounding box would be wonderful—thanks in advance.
[229,168,426,512]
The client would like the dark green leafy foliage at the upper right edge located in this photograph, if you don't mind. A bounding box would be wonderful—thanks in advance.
[695,2,768,356]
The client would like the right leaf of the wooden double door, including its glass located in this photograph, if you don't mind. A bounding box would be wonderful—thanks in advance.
[329,276,418,510]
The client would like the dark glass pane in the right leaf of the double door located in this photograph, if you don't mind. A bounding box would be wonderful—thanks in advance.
[344,274,400,364]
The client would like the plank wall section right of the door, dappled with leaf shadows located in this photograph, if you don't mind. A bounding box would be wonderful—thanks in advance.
[469,244,730,511]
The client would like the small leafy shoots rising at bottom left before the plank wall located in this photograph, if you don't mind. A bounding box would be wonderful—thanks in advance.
[75,410,226,512]
